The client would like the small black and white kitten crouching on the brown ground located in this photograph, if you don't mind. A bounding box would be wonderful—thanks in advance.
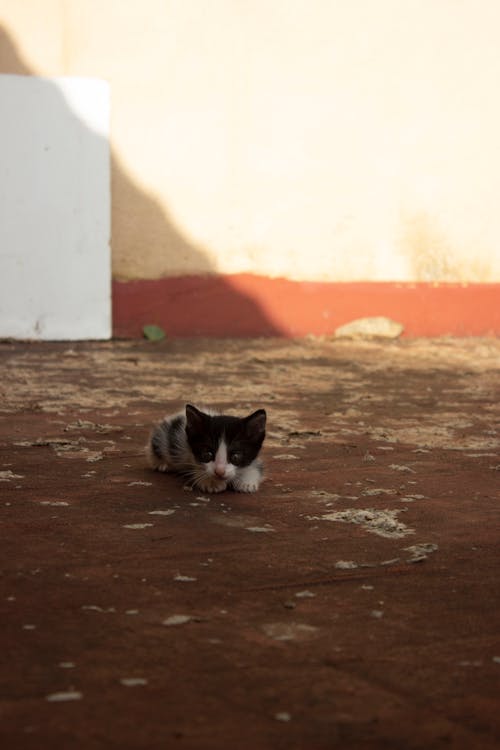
[146,404,266,492]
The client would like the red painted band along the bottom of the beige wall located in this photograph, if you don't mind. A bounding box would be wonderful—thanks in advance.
[113,274,500,338]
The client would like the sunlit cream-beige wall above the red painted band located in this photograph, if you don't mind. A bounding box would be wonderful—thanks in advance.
[0,0,500,281]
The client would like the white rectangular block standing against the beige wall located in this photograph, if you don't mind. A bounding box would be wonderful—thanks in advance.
[0,75,111,340]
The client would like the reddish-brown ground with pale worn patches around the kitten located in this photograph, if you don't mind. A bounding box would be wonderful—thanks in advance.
[0,339,500,750]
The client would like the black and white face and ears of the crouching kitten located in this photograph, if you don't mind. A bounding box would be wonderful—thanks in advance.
[186,404,266,481]
